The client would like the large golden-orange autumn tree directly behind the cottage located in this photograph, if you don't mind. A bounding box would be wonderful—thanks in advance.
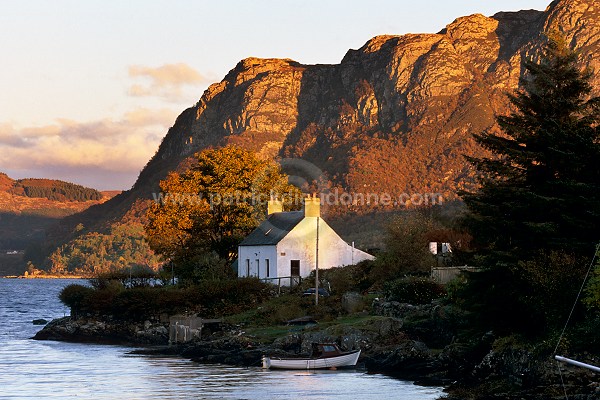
[146,147,301,280]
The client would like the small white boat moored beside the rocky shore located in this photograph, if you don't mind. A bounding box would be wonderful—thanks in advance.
[262,343,360,369]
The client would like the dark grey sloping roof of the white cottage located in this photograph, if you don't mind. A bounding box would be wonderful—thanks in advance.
[240,211,304,246]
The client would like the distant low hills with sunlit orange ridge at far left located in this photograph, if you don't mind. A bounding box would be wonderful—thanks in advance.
[0,173,120,276]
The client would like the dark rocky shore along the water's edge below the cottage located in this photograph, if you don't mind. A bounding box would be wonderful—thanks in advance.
[34,302,600,400]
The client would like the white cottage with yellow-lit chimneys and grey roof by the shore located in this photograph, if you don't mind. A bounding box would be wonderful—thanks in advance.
[238,196,374,285]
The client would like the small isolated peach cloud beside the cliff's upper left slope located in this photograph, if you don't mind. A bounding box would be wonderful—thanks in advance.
[128,63,209,102]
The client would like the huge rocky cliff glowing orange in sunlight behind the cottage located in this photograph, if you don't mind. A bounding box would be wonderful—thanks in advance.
[48,0,600,247]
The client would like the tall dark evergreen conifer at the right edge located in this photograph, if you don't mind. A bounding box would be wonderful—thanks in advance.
[463,35,600,262]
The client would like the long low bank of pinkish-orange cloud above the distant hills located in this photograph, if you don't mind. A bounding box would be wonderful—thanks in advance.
[0,109,176,189]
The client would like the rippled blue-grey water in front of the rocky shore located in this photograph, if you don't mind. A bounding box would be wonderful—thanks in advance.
[0,279,442,400]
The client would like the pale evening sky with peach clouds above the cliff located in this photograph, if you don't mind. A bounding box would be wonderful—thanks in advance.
[0,0,550,190]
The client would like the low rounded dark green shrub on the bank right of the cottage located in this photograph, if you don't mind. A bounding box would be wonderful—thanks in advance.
[383,277,445,304]
